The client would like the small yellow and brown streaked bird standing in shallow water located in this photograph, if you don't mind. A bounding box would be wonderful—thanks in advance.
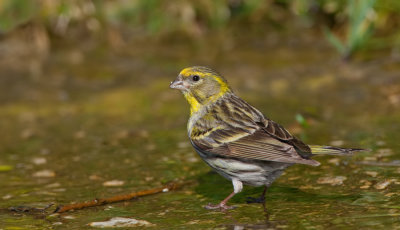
[170,66,364,210]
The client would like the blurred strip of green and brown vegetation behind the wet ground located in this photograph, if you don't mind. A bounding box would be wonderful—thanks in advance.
[0,0,400,59]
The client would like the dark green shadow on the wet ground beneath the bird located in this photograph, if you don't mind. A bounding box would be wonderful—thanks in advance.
[194,171,360,205]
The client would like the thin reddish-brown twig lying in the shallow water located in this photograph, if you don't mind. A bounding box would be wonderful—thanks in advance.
[54,182,187,213]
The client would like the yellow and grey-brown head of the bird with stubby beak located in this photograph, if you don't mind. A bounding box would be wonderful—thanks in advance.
[170,66,231,113]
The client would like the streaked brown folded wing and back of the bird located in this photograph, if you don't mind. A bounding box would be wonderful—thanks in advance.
[190,93,319,165]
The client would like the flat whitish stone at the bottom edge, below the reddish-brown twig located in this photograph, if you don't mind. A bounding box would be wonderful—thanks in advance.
[89,217,155,228]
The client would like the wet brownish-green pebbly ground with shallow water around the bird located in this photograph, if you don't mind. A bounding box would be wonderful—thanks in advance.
[0,31,400,229]
